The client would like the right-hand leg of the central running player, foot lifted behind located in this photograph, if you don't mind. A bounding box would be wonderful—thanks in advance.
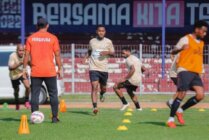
[99,72,108,102]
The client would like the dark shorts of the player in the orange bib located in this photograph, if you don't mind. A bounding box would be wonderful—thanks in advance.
[177,71,203,91]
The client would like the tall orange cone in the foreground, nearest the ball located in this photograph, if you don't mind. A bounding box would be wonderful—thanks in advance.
[18,115,30,135]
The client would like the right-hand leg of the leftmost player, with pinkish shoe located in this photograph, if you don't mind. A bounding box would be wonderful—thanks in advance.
[22,77,30,109]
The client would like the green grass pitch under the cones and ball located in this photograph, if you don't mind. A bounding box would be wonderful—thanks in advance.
[0,109,209,140]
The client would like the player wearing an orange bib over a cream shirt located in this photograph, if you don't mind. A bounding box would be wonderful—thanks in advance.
[167,21,208,128]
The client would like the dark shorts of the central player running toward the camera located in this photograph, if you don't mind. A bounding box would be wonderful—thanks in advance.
[89,71,108,86]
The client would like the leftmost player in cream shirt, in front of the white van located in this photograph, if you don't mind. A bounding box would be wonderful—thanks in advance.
[8,44,30,110]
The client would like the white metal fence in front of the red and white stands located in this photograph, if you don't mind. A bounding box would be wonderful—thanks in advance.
[61,44,209,94]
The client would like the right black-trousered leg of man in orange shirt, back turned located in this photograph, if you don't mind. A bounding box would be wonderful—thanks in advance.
[44,76,59,123]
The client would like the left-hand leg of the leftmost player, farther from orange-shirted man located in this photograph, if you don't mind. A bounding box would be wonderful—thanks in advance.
[11,79,20,110]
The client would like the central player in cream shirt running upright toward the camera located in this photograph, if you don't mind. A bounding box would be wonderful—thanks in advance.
[85,25,115,114]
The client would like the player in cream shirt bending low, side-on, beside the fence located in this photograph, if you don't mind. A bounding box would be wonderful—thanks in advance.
[113,47,145,111]
